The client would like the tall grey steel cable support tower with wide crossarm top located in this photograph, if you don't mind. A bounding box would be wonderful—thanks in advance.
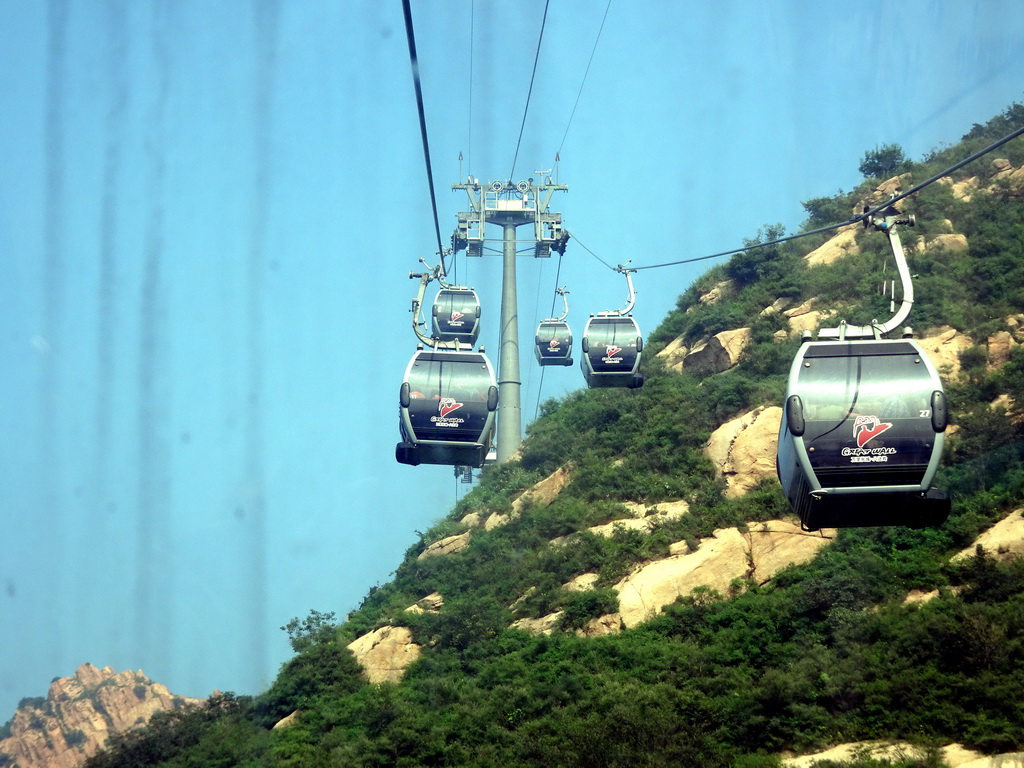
[452,175,568,463]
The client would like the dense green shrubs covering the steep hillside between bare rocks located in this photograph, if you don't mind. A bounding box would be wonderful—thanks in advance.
[90,104,1024,768]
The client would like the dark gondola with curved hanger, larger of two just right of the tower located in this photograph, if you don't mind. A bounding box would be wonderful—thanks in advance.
[580,266,643,388]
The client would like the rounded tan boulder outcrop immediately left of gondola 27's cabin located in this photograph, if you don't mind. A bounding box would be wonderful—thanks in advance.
[705,406,782,498]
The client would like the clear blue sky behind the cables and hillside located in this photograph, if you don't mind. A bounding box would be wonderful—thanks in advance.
[0,0,1024,720]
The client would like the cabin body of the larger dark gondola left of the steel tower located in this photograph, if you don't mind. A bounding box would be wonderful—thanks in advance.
[395,348,498,467]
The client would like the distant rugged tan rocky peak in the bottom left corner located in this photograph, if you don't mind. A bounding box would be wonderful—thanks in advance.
[0,664,201,768]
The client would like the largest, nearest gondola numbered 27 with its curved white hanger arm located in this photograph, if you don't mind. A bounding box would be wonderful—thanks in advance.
[776,216,950,530]
